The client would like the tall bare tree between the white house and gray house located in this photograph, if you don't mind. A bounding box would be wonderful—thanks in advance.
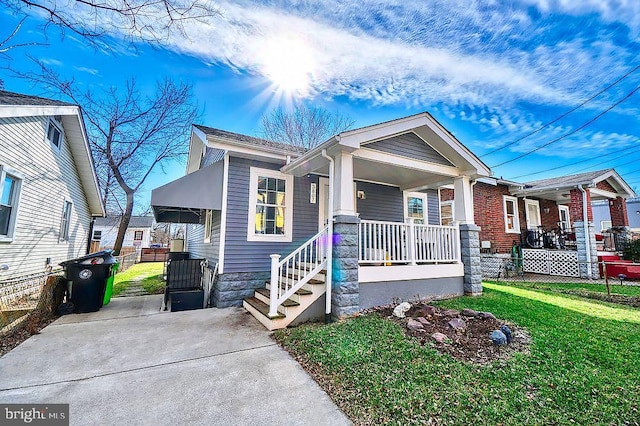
[29,64,198,253]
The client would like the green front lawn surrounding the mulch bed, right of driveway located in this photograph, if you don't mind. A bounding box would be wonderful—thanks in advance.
[276,284,640,425]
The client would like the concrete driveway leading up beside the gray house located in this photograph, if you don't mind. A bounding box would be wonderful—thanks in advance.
[0,296,349,425]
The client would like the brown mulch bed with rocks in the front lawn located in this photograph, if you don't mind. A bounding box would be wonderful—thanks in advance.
[370,302,530,364]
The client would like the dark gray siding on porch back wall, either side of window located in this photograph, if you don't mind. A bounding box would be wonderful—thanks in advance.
[356,182,440,225]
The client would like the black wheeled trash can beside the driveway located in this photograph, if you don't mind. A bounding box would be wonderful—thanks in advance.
[60,250,116,314]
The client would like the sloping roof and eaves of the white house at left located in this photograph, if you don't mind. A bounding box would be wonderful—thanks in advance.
[0,91,105,216]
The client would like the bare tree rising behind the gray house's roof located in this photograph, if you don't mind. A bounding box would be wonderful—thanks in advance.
[260,104,355,149]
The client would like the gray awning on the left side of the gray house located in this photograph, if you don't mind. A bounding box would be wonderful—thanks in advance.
[151,161,224,223]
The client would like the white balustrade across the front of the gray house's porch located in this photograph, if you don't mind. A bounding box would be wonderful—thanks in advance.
[358,220,460,265]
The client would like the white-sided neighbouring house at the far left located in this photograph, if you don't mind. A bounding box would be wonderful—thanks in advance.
[0,91,104,281]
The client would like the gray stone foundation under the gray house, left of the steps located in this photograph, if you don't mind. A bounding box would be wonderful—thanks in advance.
[211,271,271,308]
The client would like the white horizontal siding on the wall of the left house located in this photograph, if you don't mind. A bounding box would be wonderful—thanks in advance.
[0,117,91,280]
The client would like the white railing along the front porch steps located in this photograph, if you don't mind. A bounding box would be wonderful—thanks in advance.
[269,227,330,317]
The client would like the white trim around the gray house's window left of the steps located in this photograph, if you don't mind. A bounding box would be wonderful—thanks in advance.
[247,167,293,243]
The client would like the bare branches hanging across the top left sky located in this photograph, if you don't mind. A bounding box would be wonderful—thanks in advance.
[0,0,220,43]
